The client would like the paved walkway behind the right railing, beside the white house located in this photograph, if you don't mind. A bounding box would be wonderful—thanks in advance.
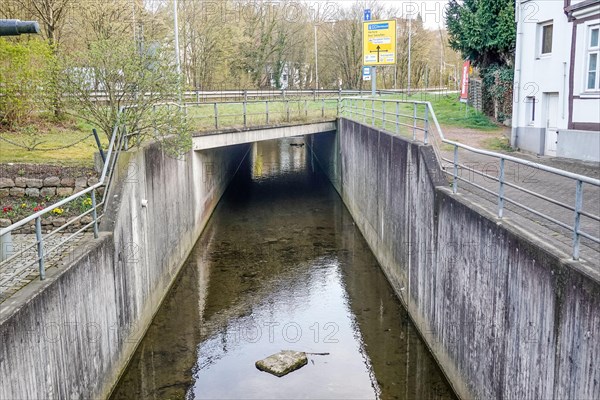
[441,147,600,271]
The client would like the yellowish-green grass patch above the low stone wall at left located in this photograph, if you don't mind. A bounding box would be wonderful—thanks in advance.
[0,119,108,167]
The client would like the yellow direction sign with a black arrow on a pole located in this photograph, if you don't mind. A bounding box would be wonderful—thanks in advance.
[363,20,396,65]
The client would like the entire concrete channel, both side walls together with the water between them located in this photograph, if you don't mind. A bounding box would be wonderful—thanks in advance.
[0,118,600,399]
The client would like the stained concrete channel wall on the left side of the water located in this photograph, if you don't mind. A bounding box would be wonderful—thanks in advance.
[0,145,248,399]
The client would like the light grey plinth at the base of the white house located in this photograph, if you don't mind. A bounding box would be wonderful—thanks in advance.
[556,130,600,162]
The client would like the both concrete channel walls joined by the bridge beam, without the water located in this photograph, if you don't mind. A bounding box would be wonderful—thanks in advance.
[0,108,600,399]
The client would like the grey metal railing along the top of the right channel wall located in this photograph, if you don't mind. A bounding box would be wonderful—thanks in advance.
[341,98,600,260]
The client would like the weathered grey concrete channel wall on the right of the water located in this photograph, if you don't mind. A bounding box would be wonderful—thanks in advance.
[308,119,600,399]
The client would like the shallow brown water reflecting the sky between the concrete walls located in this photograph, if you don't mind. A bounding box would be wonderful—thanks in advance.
[112,138,455,399]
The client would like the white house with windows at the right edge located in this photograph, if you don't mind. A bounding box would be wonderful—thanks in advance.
[511,0,600,161]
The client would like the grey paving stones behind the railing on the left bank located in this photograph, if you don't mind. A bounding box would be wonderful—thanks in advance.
[0,233,94,303]
